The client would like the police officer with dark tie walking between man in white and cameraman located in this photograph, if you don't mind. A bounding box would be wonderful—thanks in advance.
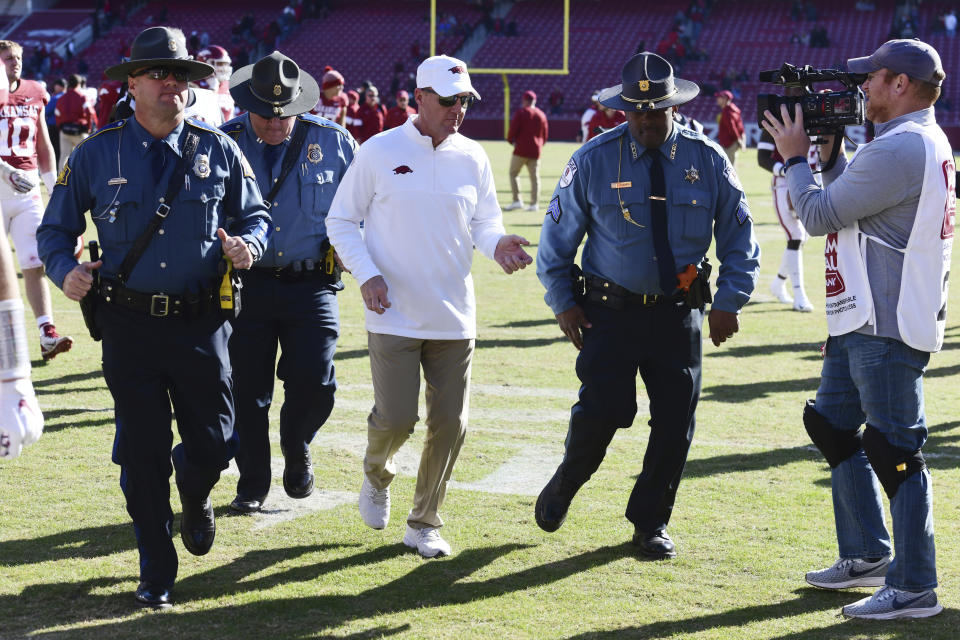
[535,53,760,559]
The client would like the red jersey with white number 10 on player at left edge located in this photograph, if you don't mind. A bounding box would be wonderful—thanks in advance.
[0,79,50,171]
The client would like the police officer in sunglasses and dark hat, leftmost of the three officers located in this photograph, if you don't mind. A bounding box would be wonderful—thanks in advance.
[37,27,270,608]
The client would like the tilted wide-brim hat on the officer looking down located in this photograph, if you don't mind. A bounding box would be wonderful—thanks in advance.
[230,51,320,118]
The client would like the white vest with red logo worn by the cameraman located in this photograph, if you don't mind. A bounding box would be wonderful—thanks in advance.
[824,122,956,352]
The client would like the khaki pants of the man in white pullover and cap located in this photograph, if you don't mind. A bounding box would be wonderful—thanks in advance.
[363,333,474,529]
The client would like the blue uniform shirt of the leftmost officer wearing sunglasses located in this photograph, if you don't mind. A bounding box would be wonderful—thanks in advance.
[37,117,271,294]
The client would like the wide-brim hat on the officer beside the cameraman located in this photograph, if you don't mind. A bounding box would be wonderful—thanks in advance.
[598,52,700,111]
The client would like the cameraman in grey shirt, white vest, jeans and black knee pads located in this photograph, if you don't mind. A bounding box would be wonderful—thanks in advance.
[763,40,956,619]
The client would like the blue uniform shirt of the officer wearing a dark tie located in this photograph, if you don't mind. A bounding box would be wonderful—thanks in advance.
[537,123,760,314]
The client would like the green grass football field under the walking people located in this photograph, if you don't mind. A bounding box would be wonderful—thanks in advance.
[0,142,960,640]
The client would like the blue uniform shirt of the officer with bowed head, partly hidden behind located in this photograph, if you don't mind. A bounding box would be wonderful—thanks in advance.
[221,113,357,267]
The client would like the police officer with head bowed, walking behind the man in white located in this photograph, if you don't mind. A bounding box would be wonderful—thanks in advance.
[223,51,357,513]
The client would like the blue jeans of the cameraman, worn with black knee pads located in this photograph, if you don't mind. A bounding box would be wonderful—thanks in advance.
[816,333,937,591]
